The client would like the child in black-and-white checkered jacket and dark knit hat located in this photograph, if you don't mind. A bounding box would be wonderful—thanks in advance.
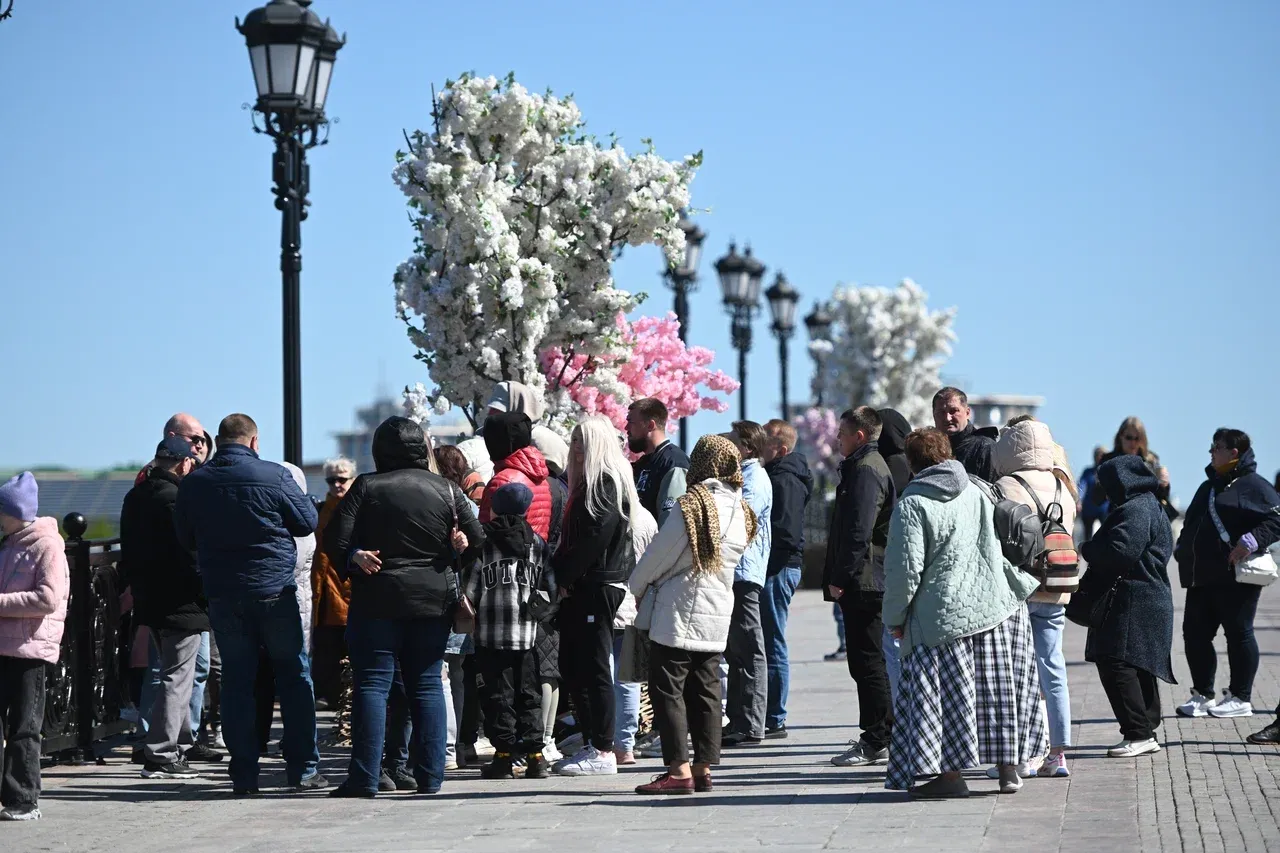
[462,483,556,779]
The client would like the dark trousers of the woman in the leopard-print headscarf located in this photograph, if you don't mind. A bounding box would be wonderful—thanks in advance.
[649,643,721,767]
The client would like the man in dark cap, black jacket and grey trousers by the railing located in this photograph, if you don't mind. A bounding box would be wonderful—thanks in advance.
[120,435,211,779]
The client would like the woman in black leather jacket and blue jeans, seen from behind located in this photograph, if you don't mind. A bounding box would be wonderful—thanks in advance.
[325,418,484,797]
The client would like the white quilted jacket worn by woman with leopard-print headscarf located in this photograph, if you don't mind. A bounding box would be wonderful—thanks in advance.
[628,480,746,652]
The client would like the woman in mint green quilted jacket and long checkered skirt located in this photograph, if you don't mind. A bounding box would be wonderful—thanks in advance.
[883,429,1048,797]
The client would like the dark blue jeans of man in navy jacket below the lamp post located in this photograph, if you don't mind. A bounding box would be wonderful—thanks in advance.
[209,587,320,790]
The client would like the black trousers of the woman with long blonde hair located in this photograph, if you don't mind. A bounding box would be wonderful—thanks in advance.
[557,583,625,752]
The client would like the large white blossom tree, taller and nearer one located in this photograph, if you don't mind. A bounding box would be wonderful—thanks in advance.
[394,74,701,423]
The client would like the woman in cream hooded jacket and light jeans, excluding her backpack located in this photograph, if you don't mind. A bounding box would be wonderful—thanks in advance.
[988,419,1079,776]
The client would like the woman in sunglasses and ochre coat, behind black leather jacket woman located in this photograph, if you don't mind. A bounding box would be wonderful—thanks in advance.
[311,456,356,711]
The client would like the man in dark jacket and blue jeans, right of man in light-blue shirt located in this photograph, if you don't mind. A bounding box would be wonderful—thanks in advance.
[760,420,813,738]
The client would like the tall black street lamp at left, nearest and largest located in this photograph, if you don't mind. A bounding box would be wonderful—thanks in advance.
[236,0,347,465]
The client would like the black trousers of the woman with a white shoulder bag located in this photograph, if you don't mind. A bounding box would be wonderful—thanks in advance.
[1183,583,1262,702]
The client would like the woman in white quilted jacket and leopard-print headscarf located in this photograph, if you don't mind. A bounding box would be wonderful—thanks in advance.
[630,435,756,794]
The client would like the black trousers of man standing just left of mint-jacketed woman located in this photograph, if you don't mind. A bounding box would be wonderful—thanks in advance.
[838,592,893,749]
